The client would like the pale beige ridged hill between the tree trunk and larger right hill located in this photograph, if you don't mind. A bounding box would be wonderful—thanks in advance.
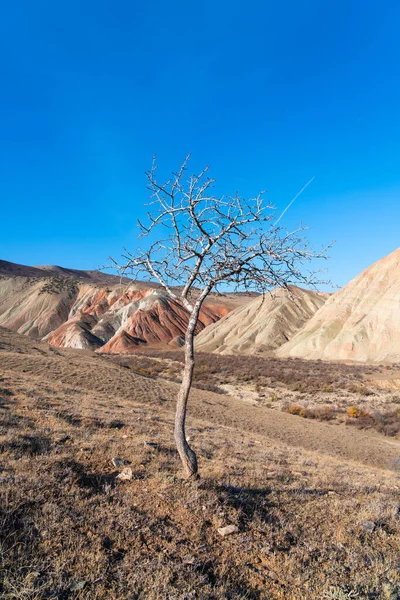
[195,286,327,354]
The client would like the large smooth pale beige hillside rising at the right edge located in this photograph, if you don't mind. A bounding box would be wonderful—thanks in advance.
[277,249,400,362]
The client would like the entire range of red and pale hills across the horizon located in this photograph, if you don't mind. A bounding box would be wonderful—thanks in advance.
[0,249,400,362]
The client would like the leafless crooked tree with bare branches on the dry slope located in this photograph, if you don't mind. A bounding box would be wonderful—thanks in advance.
[112,155,325,477]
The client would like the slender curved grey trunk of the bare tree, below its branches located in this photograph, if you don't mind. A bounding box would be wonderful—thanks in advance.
[175,305,200,479]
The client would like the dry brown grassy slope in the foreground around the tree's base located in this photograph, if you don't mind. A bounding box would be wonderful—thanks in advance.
[0,329,400,600]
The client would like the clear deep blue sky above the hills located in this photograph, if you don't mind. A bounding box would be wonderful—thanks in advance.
[0,0,400,285]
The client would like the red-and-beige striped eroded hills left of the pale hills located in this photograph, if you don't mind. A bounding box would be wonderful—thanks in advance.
[0,261,251,352]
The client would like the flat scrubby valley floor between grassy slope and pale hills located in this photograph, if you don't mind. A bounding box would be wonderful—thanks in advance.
[111,349,400,437]
